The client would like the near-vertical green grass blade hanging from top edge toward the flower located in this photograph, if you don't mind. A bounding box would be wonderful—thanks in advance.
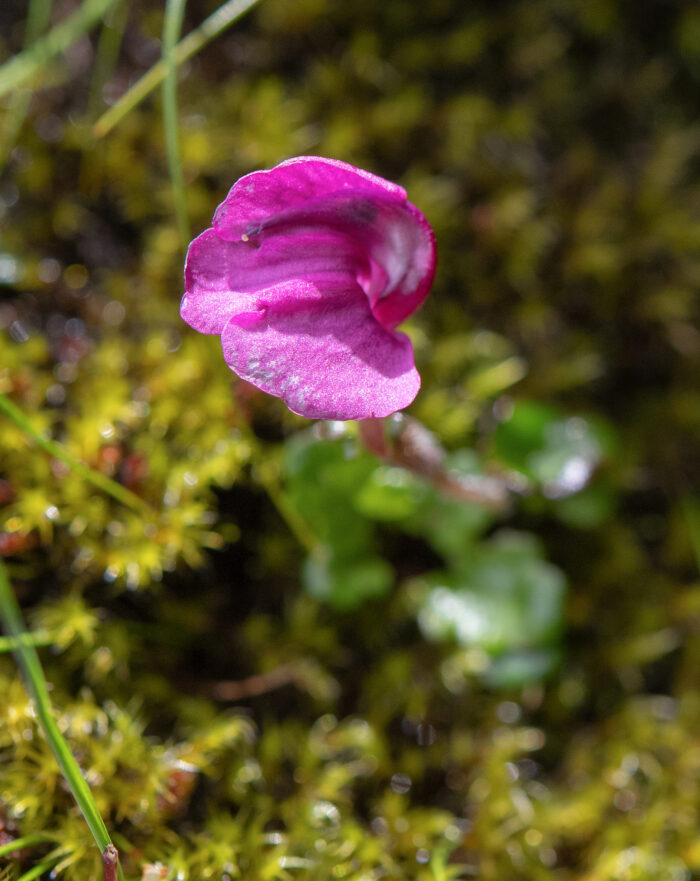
[162,0,191,251]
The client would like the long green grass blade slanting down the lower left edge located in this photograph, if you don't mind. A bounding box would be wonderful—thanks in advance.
[0,559,120,877]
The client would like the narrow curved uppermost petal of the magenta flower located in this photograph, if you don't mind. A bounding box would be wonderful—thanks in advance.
[214,156,406,241]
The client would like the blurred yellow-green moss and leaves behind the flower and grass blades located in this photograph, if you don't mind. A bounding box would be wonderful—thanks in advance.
[0,0,700,881]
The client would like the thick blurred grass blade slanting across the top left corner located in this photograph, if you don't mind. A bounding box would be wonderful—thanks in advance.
[0,0,116,98]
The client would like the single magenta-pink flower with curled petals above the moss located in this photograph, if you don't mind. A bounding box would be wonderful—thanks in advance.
[180,156,435,419]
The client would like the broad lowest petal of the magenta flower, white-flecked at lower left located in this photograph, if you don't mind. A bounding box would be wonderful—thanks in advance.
[221,278,420,419]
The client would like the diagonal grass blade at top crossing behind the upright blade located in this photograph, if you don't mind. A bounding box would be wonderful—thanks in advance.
[93,0,258,138]
